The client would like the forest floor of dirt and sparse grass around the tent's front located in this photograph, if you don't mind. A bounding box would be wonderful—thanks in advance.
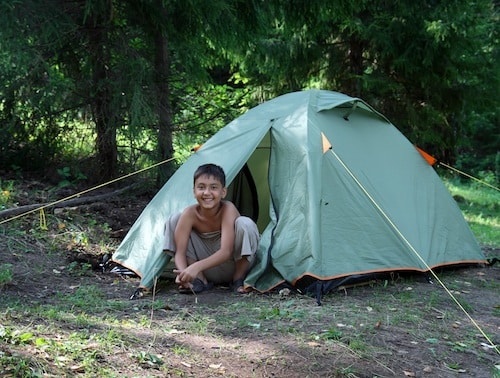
[0,182,500,378]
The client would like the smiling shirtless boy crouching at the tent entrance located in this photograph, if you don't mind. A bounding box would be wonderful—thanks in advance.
[164,164,260,293]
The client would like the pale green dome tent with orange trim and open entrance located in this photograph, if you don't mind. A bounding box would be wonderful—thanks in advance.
[112,90,485,293]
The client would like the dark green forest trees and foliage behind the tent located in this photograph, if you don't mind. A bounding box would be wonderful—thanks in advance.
[0,0,500,183]
